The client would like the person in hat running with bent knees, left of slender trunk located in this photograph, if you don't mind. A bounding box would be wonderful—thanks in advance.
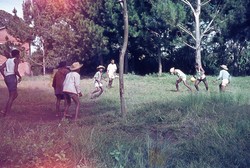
[91,65,105,99]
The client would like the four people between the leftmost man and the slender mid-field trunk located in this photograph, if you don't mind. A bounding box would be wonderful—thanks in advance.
[52,59,117,119]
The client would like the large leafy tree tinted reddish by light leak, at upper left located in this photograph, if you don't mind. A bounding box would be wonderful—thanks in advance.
[24,0,107,74]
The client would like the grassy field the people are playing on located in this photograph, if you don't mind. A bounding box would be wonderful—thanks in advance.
[0,74,250,168]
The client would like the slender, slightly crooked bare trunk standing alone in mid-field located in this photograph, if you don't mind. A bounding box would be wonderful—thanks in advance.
[119,0,128,118]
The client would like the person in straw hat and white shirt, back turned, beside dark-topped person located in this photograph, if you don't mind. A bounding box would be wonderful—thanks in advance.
[63,62,83,120]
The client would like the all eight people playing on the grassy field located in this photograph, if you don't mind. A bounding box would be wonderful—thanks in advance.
[0,49,231,119]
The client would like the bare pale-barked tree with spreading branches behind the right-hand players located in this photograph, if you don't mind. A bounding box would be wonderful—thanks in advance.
[156,0,223,65]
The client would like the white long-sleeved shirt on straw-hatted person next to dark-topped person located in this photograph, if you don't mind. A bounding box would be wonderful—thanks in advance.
[63,72,81,94]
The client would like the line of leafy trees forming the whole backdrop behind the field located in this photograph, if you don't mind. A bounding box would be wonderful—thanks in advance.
[0,0,250,75]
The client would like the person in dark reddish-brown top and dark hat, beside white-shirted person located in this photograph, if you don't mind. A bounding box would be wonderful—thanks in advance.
[52,61,70,116]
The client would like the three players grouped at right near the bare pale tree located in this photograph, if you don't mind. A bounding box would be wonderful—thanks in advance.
[170,63,231,91]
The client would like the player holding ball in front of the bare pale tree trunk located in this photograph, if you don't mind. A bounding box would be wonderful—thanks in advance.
[194,63,208,91]
